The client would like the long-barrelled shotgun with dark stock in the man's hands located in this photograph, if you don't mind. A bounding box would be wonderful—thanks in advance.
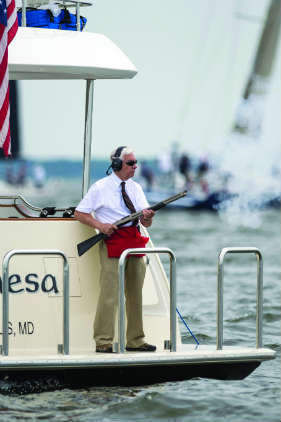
[77,190,187,256]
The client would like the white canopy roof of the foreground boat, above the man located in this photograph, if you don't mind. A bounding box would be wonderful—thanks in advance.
[8,27,137,80]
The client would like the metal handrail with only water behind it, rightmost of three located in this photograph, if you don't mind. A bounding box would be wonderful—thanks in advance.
[217,247,263,350]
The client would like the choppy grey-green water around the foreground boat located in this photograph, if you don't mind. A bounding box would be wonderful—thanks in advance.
[0,165,280,422]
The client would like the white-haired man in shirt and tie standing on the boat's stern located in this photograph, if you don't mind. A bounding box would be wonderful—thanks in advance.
[74,146,156,353]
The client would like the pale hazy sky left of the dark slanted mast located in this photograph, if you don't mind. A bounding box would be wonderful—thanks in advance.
[14,0,276,159]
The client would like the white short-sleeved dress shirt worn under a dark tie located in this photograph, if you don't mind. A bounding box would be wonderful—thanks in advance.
[76,172,149,226]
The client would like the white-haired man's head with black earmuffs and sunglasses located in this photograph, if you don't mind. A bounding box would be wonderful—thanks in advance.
[110,146,137,180]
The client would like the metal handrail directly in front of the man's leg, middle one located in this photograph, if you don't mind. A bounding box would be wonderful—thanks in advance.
[118,248,177,353]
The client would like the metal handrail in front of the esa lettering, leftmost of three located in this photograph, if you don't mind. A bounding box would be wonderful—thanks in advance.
[2,249,69,356]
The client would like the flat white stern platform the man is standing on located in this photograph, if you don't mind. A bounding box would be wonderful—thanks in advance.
[0,345,275,371]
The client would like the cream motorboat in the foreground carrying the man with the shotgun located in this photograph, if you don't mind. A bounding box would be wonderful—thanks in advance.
[0,1,275,394]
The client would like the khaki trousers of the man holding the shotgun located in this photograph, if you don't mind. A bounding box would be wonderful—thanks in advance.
[94,241,146,347]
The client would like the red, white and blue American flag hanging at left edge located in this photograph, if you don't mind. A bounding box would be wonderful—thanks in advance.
[0,0,18,156]
